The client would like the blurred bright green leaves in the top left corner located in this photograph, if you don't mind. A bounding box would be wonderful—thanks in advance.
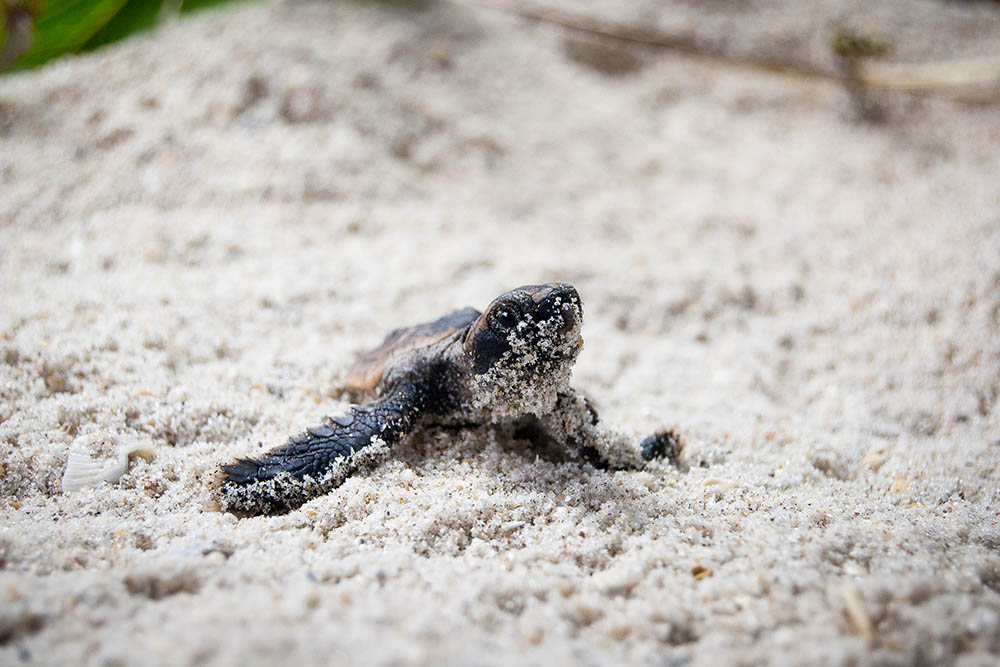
[0,0,252,71]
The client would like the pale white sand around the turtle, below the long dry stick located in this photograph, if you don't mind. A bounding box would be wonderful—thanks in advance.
[0,0,1000,665]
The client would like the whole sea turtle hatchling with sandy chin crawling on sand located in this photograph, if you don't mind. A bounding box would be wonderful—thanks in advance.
[219,283,679,514]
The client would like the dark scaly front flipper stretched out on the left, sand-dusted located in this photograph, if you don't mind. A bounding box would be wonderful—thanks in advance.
[219,383,424,514]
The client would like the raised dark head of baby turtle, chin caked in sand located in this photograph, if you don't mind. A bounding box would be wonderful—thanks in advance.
[462,283,583,414]
